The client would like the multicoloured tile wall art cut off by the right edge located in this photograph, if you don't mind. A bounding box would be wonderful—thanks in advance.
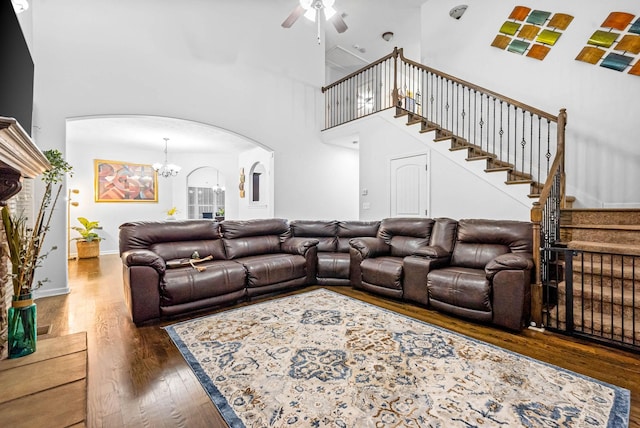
[576,12,640,76]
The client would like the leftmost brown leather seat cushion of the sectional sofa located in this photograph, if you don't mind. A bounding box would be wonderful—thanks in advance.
[160,260,246,306]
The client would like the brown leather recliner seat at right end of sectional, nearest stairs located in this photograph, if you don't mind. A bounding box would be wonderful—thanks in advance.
[427,220,533,330]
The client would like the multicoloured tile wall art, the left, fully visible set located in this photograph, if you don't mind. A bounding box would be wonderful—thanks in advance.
[491,6,573,61]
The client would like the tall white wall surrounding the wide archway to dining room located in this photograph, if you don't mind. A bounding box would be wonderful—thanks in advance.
[30,0,357,296]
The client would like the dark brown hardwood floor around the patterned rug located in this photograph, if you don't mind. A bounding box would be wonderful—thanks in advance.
[36,255,640,428]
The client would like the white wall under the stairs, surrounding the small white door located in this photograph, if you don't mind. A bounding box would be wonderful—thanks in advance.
[324,110,530,221]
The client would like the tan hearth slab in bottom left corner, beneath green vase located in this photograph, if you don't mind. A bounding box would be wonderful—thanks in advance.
[0,332,87,427]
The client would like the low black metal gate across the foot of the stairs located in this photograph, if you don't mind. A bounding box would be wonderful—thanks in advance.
[543,248,640,351]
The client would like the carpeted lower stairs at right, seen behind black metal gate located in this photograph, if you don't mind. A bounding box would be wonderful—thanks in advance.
[545,209,640,349]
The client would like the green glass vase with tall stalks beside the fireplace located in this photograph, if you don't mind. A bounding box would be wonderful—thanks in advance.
[2,150,73,358]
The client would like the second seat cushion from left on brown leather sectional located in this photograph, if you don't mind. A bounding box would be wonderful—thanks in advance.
[237,253,307,287]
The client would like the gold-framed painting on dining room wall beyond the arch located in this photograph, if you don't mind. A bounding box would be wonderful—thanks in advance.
[93,159,158,202]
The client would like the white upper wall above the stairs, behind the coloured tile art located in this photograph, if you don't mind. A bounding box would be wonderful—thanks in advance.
[421,0,640,207]
